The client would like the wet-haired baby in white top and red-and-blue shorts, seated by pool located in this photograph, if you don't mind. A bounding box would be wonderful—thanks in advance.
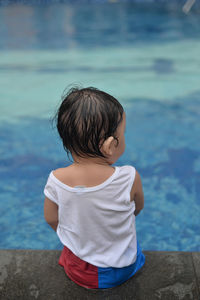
[44,88,145,289]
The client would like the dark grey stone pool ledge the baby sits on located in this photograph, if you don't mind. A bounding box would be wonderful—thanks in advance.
[0,250,200,300]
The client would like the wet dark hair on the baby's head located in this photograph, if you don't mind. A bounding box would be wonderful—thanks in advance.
[56,87,124,157]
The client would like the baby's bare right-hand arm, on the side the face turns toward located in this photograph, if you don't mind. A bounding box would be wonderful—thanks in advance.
[131,171,144,216]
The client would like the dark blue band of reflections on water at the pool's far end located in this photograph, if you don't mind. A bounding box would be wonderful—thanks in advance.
[0,2,199,49]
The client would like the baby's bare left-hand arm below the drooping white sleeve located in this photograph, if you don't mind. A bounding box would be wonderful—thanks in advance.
[44,197,58,231]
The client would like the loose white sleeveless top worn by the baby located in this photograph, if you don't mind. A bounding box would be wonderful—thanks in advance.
[44,166,137,268]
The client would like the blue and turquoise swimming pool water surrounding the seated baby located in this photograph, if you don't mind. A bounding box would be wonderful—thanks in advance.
[0,1,200,251]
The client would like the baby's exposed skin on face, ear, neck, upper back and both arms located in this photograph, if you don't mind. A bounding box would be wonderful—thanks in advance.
[44,114,144,231]
